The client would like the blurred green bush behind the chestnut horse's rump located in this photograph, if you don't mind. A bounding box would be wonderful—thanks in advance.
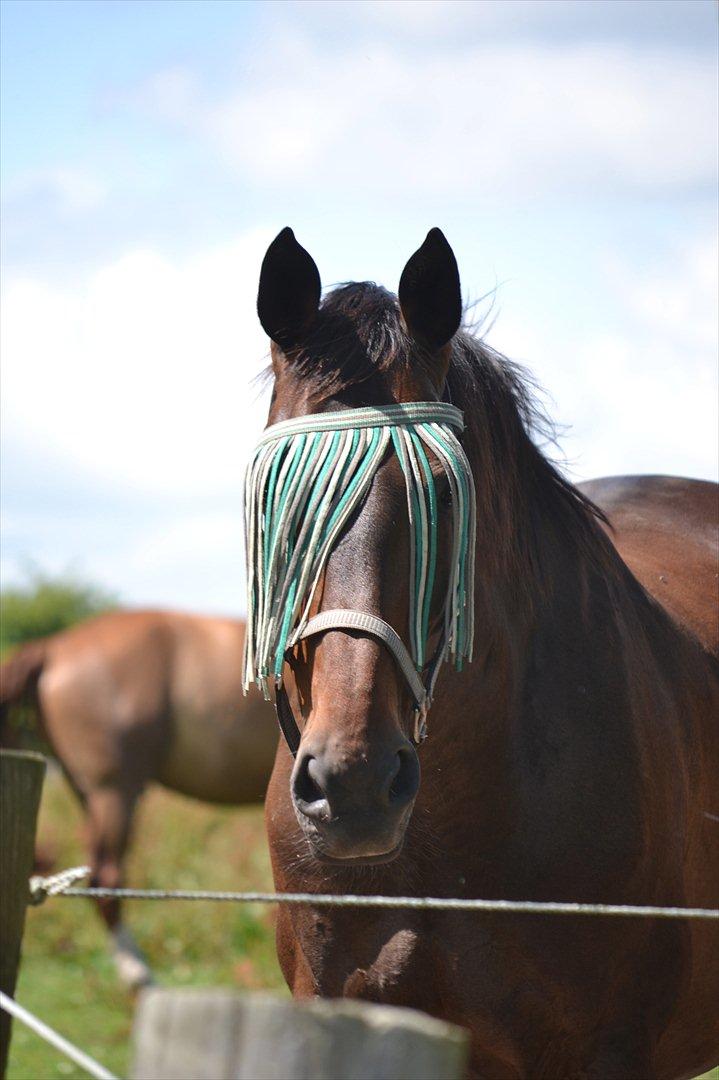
[0,570,118,653]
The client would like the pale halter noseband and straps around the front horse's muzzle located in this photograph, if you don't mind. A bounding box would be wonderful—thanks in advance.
[274,608,433,757]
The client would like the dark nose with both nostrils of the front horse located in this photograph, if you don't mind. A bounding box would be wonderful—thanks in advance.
[293,742,419,825]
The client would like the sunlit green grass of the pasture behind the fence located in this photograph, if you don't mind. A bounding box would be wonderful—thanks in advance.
[8,771,719,1080]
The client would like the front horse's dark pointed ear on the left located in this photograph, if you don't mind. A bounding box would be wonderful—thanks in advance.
[257,228,322,350]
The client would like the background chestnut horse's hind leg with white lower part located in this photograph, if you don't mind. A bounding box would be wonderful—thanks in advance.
[86,786,152,989]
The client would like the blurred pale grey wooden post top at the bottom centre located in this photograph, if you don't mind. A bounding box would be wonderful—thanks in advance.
[132,988,467,1080]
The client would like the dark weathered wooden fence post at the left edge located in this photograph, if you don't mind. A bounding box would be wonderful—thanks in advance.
[0,750,45,1078]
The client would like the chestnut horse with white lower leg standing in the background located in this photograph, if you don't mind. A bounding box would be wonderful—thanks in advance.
[0,611,277,986]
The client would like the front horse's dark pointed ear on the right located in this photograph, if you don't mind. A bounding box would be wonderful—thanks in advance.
[399,229,462,349]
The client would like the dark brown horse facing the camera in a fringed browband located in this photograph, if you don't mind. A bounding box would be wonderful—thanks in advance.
[258,229,719,1078]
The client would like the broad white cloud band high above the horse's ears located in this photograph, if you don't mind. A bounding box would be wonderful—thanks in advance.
[141,36,717,199]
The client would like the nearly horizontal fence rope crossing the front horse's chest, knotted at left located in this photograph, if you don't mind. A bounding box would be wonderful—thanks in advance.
[30,866,719,919]
